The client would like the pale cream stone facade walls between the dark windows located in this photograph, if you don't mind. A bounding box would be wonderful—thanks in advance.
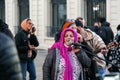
[1,0,120,49]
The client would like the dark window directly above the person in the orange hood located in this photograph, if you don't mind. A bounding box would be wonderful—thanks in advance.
[18,0,29,24]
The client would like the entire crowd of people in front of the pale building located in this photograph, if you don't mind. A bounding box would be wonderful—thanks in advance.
[0,17,120,80]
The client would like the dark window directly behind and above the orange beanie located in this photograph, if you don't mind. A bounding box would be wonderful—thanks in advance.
[47,0,66,37]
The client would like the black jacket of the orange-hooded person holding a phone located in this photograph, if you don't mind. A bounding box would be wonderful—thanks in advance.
[15,30,39,62]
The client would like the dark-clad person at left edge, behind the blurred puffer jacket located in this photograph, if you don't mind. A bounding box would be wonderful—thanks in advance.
[0,19,14,39]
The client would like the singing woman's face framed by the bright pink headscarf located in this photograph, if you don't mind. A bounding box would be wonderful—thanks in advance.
[64,31,74,46]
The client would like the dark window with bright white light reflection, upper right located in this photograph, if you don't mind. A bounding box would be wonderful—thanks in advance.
[87,0,106,26]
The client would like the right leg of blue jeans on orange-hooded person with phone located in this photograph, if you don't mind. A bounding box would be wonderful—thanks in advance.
[27,58,36,80]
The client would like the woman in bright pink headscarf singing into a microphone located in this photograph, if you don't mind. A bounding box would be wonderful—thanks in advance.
[43,28,91,80]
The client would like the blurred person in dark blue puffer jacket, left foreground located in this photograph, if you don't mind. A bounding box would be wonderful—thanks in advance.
[0,33,22,80]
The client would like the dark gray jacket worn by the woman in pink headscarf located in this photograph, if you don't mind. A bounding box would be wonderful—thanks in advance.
[43,49,91,80]
